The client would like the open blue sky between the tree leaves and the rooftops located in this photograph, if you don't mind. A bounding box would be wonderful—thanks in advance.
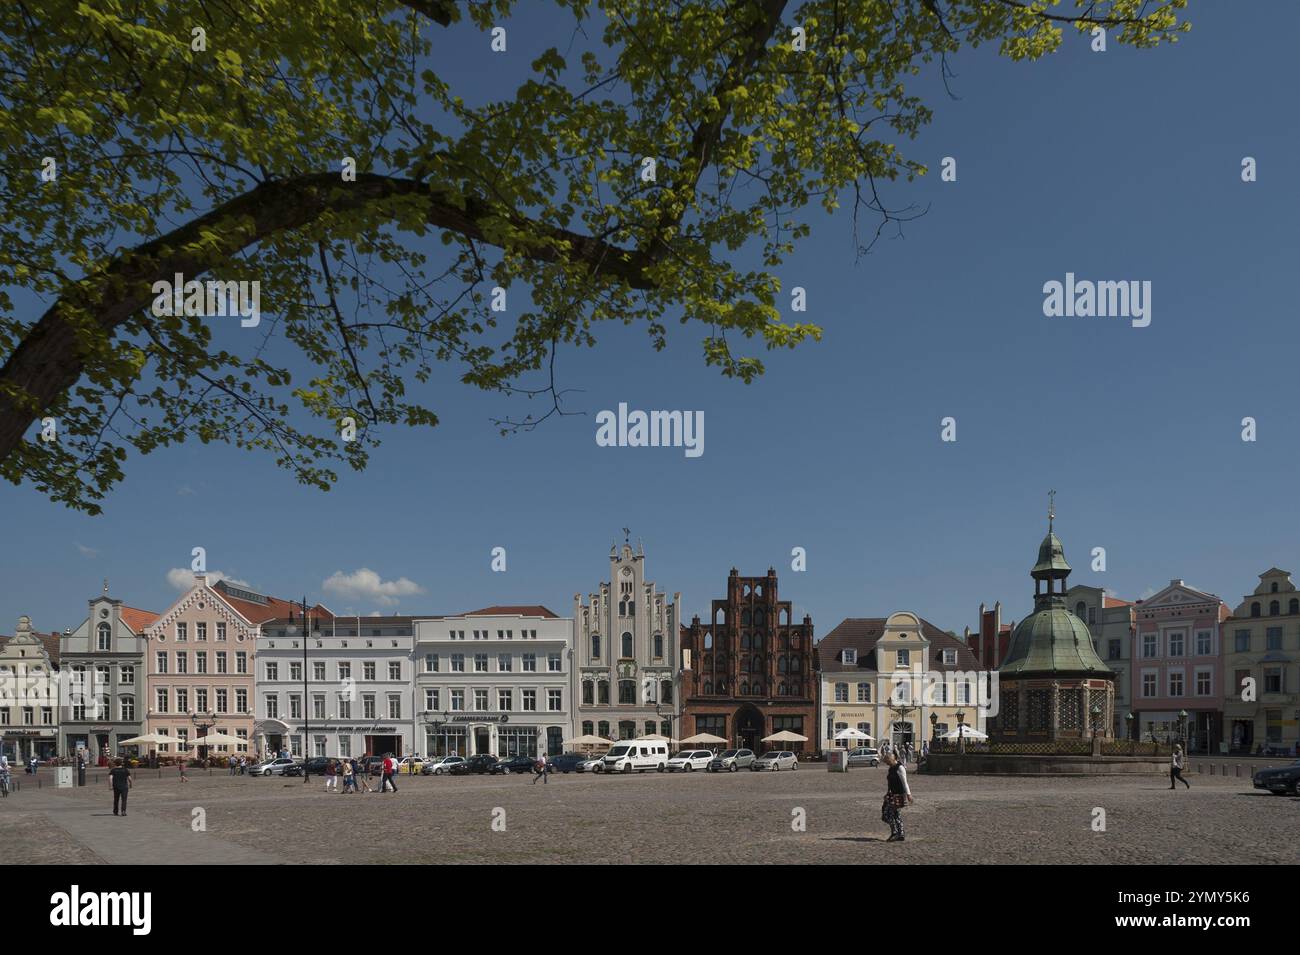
[0,1,1300,634]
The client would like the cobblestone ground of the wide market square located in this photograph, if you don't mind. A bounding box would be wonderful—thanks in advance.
[0,765,1300,864]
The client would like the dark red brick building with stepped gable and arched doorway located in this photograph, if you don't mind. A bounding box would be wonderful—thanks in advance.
[679,568,818,752]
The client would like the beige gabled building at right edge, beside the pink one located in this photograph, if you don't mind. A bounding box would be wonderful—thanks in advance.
[1223,567,1300,754]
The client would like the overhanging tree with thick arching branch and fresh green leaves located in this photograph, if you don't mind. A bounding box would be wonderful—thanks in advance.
[0,0,1188,513]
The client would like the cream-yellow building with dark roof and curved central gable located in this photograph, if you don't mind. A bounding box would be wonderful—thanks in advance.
[818,611,985,751]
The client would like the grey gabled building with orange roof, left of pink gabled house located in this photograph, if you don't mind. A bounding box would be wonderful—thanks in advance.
[59,579,159,763]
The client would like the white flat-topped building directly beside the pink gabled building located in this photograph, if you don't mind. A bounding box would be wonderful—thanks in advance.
[256,615,420,758]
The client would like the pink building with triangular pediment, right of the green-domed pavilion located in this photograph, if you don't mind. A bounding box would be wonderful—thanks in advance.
[1130,579,1229,752]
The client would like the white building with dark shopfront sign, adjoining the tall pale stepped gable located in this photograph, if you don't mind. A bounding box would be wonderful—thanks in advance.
[415,605,573,758]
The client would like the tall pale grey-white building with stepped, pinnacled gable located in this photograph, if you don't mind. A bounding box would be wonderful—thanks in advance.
[573,543,681,739]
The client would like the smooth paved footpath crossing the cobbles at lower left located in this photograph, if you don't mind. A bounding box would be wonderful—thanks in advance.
[0,785,283,865]
